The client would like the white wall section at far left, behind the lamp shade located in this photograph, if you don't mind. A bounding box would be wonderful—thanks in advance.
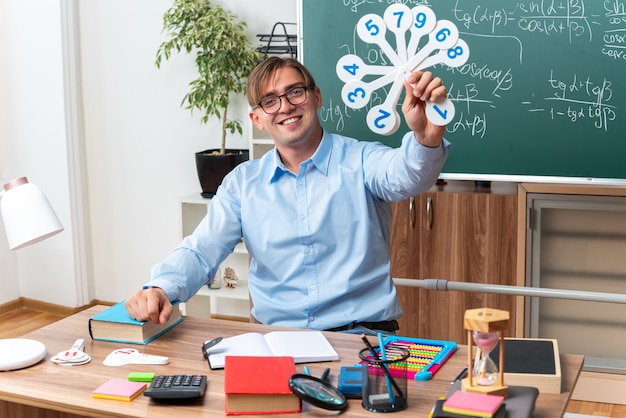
[0,0,77,306]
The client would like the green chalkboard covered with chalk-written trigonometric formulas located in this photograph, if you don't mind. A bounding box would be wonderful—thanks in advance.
[300,0,626,184]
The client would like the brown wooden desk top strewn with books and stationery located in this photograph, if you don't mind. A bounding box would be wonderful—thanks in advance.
[0,306,583,418]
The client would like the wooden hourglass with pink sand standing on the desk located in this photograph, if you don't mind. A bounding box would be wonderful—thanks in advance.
[461,308,509,396]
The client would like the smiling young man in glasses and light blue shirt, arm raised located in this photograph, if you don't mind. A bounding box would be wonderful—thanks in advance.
[126,57,449,333]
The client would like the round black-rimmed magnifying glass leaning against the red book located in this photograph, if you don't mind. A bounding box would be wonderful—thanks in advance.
[289,373,348,411]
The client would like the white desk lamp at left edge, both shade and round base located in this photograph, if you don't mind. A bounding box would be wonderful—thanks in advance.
[0,177,63,371]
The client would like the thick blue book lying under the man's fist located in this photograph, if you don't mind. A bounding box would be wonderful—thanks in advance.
[89,301,183,344]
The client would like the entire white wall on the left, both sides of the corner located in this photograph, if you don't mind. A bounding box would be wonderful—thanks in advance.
[0,0,297,307]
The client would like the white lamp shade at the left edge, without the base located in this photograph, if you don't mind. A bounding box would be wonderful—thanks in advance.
[0,177,63,250]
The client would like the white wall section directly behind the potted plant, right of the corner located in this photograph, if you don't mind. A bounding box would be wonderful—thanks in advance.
[80,0,296,301]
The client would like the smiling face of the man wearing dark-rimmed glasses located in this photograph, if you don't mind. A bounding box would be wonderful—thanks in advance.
[250,67,322,147]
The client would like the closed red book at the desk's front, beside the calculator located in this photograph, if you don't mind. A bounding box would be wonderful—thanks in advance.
[224,356,302,415]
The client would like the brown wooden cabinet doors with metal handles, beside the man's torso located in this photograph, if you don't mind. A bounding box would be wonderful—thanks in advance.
[392,186,517,344]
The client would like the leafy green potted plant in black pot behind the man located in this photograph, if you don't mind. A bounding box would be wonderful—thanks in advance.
[155,0,260,197]
